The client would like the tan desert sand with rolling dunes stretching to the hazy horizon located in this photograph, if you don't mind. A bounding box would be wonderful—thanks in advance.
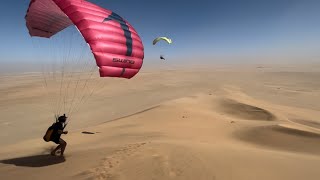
[0,65,320,180]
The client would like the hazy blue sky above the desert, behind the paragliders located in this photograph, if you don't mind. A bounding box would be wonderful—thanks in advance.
[0,0,320,69]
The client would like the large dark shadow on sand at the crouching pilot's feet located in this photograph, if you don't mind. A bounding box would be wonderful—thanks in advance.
[0,154,66,167]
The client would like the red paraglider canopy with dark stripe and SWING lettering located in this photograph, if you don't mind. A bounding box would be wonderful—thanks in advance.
[25,0,144,79]
